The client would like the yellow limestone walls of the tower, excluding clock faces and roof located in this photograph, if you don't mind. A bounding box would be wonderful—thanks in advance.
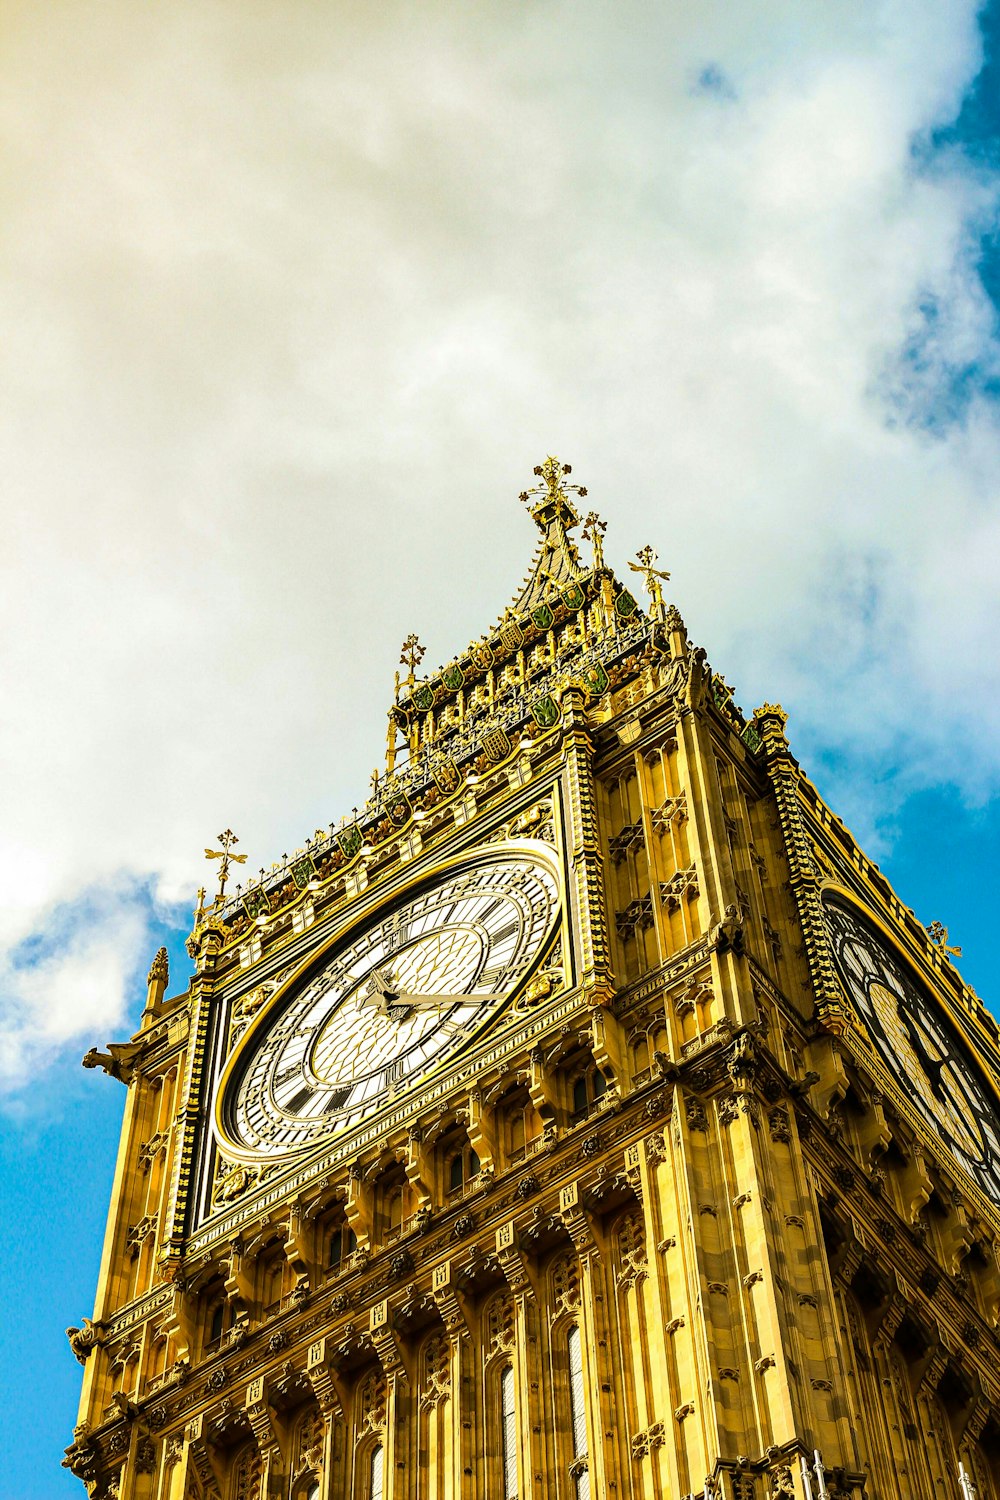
[67,624,1000,1500]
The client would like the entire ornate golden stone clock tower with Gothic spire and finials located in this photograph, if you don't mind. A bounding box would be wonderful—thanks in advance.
[66,459,1000,1500]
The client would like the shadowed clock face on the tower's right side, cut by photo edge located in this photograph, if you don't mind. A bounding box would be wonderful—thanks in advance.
[825,900,1000,1203]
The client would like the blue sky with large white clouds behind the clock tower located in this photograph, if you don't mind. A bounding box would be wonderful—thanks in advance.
[0,0,1000,1500]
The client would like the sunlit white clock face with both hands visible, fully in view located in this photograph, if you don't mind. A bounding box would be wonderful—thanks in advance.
[216,840,559,1157]
